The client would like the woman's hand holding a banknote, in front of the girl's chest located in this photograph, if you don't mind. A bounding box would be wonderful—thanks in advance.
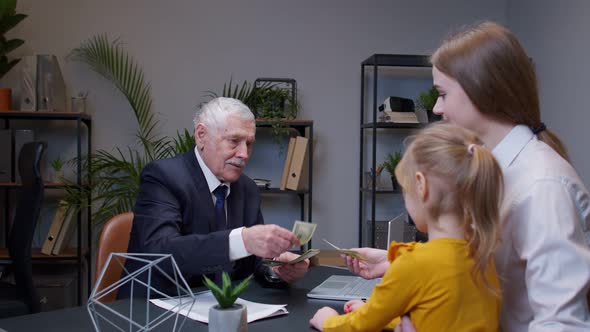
[341,248,389,279]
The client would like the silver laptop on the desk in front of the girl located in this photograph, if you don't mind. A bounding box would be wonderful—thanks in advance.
[307,275,381,301]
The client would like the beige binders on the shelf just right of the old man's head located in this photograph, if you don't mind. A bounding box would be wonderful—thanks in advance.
[281,136,309,190]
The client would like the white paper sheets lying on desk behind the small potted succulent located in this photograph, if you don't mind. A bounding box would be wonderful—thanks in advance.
[150,291,289,323]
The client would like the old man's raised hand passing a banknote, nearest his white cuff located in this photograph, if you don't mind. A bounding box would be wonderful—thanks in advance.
[242,225,301,258]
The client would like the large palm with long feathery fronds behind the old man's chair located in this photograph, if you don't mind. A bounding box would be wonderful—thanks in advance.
[64,34,194,241]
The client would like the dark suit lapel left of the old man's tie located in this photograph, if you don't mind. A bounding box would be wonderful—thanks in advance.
[183,146,217,232]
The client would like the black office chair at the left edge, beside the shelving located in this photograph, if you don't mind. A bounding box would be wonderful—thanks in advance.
[0,142,46,318]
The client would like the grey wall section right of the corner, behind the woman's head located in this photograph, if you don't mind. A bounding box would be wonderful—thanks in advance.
[508,0,590,185]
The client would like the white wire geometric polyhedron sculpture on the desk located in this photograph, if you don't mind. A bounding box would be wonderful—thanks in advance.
[87,253,195,332]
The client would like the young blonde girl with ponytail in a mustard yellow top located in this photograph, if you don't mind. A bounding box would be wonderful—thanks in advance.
[310,124,503,331]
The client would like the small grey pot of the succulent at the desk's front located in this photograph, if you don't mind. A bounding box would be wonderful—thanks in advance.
[209,304,248,332]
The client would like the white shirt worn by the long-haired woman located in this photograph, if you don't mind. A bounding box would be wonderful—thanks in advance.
[492,125,590,332]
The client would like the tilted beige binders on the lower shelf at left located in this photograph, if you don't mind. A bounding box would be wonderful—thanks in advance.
[41,201,74,255]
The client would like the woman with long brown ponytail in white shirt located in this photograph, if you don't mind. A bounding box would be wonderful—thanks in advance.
[431,22,590,332]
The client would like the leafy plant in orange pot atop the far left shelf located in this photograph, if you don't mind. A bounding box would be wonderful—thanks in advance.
[0,0,27,111]
